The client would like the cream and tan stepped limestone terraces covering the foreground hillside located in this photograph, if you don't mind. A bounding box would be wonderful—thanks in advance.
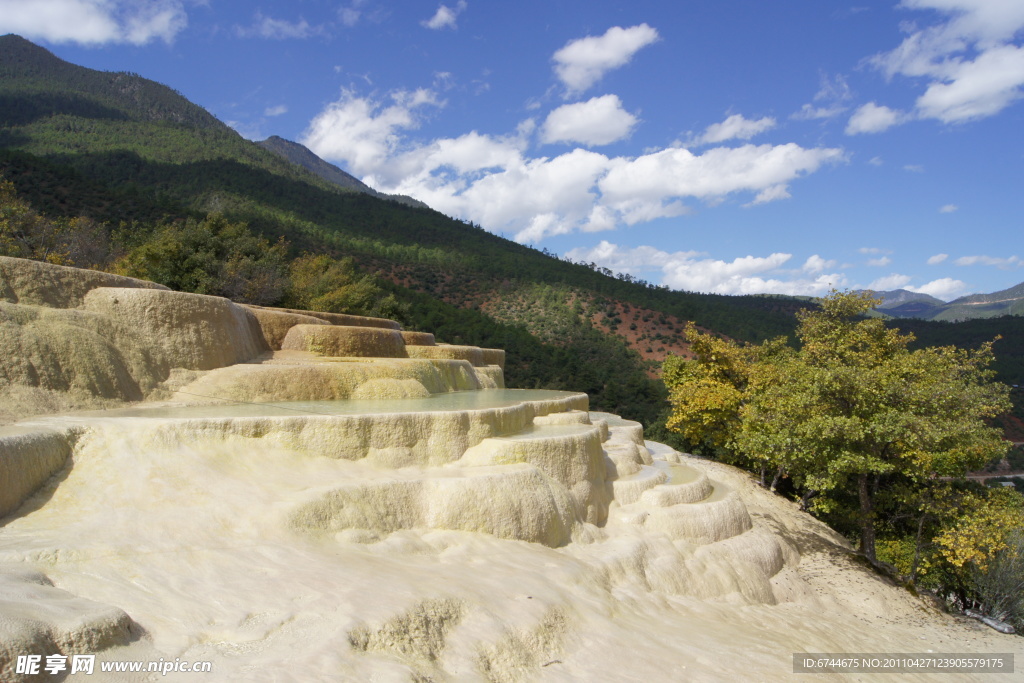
[0,258,1024,681]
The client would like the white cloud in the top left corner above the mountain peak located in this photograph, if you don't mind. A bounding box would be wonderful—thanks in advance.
[0,0,188,45]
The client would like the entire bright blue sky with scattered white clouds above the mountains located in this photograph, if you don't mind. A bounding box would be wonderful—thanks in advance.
[0,0,1024,299]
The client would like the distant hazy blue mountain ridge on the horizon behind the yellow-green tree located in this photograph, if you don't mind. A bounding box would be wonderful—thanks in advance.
[874,283,1024,323]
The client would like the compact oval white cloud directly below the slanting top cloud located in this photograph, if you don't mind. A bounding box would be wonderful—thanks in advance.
[541,95,639,146]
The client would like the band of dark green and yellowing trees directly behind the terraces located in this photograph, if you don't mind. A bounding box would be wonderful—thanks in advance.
[0,180,666,424]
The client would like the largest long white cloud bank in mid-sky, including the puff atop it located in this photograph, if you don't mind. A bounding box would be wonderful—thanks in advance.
[301,90,845,242]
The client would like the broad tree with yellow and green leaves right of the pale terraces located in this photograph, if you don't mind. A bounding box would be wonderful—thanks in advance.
[665,292,1010,561]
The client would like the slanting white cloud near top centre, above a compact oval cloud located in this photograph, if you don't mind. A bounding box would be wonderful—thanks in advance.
[552,24,658,93]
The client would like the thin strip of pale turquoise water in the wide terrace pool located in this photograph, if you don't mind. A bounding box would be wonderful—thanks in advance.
[88,389,585,418]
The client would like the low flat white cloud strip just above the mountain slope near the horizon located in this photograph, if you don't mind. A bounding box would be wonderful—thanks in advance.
[566,241,846,296]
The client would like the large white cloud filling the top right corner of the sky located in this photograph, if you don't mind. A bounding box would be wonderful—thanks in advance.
[871,0,1024,123]
